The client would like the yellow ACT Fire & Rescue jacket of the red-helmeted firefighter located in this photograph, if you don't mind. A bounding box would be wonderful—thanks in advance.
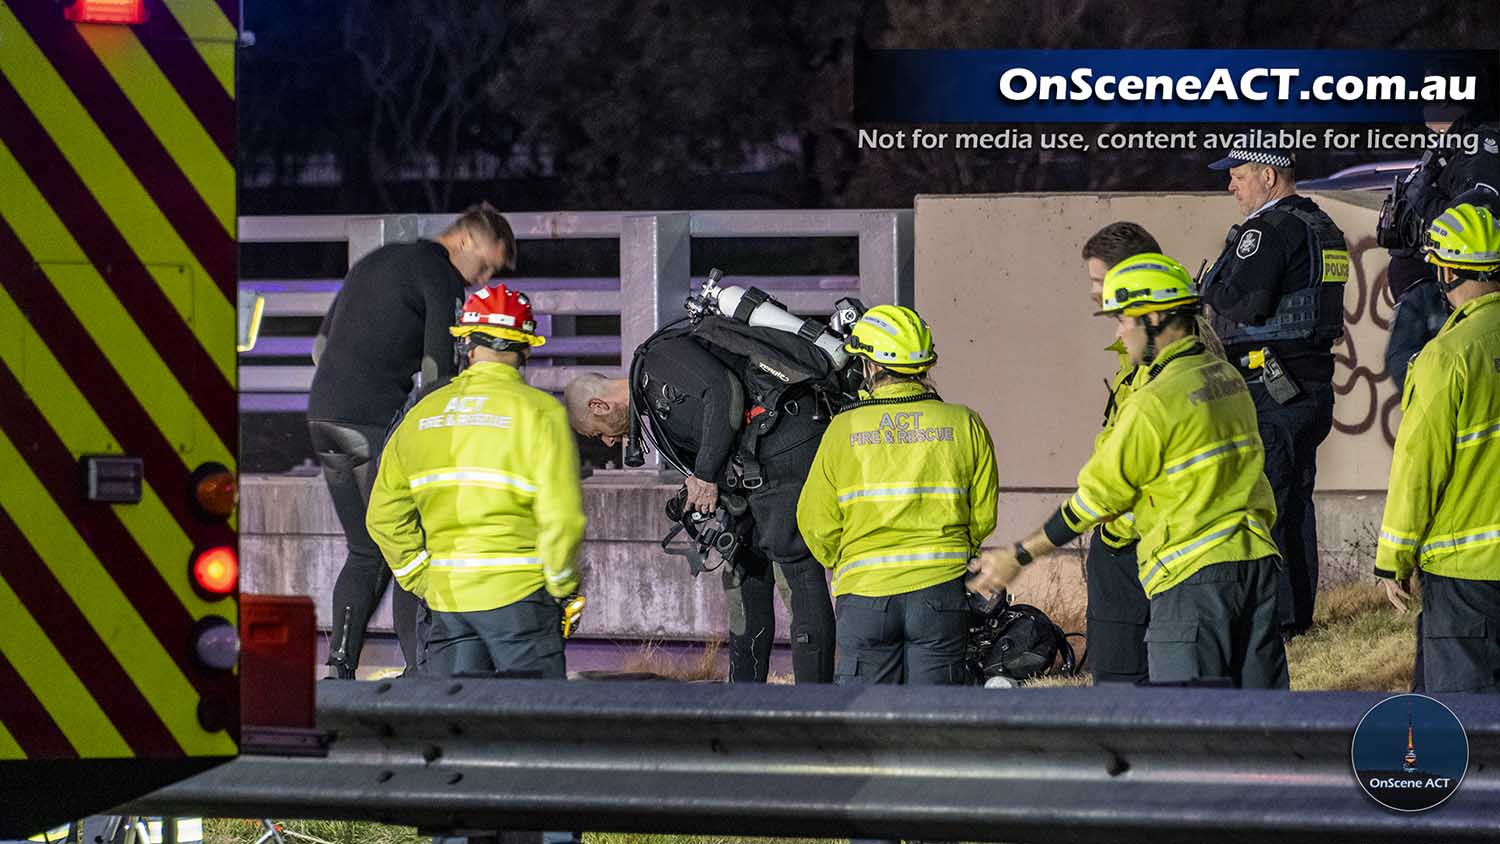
[366,363,585,612]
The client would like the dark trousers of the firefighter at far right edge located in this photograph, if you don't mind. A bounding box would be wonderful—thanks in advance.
[1418,573,1500,694]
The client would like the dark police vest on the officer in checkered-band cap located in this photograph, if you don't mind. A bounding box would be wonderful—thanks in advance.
[1203,208,1349,346]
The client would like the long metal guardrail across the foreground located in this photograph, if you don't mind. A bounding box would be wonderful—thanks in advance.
[123,681,1500,844]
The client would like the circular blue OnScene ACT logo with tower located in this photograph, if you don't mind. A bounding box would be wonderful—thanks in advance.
[1350,694,1469,811]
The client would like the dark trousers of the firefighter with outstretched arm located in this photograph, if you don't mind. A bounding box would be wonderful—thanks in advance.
[1146,556,1289,688]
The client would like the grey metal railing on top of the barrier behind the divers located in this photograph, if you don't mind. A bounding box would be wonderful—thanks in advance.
[239,210,912,412]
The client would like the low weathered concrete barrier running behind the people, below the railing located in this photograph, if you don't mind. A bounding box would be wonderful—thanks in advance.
[240,472,1385,642]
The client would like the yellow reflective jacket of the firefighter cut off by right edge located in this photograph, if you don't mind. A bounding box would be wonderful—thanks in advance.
[1376,292,1500,580]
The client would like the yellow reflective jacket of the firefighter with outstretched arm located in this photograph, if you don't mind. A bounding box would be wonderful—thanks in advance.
[1062,337,1277,595]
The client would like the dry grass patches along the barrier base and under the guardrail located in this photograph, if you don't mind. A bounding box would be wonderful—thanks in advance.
[204,582,1416,844]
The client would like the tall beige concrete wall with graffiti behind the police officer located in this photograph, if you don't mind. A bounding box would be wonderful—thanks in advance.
[915,192,1400,491]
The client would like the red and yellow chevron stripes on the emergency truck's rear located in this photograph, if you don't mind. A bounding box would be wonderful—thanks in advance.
[0,0,239,763]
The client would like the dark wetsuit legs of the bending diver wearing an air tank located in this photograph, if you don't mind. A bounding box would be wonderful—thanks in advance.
[723,399,834,684]
